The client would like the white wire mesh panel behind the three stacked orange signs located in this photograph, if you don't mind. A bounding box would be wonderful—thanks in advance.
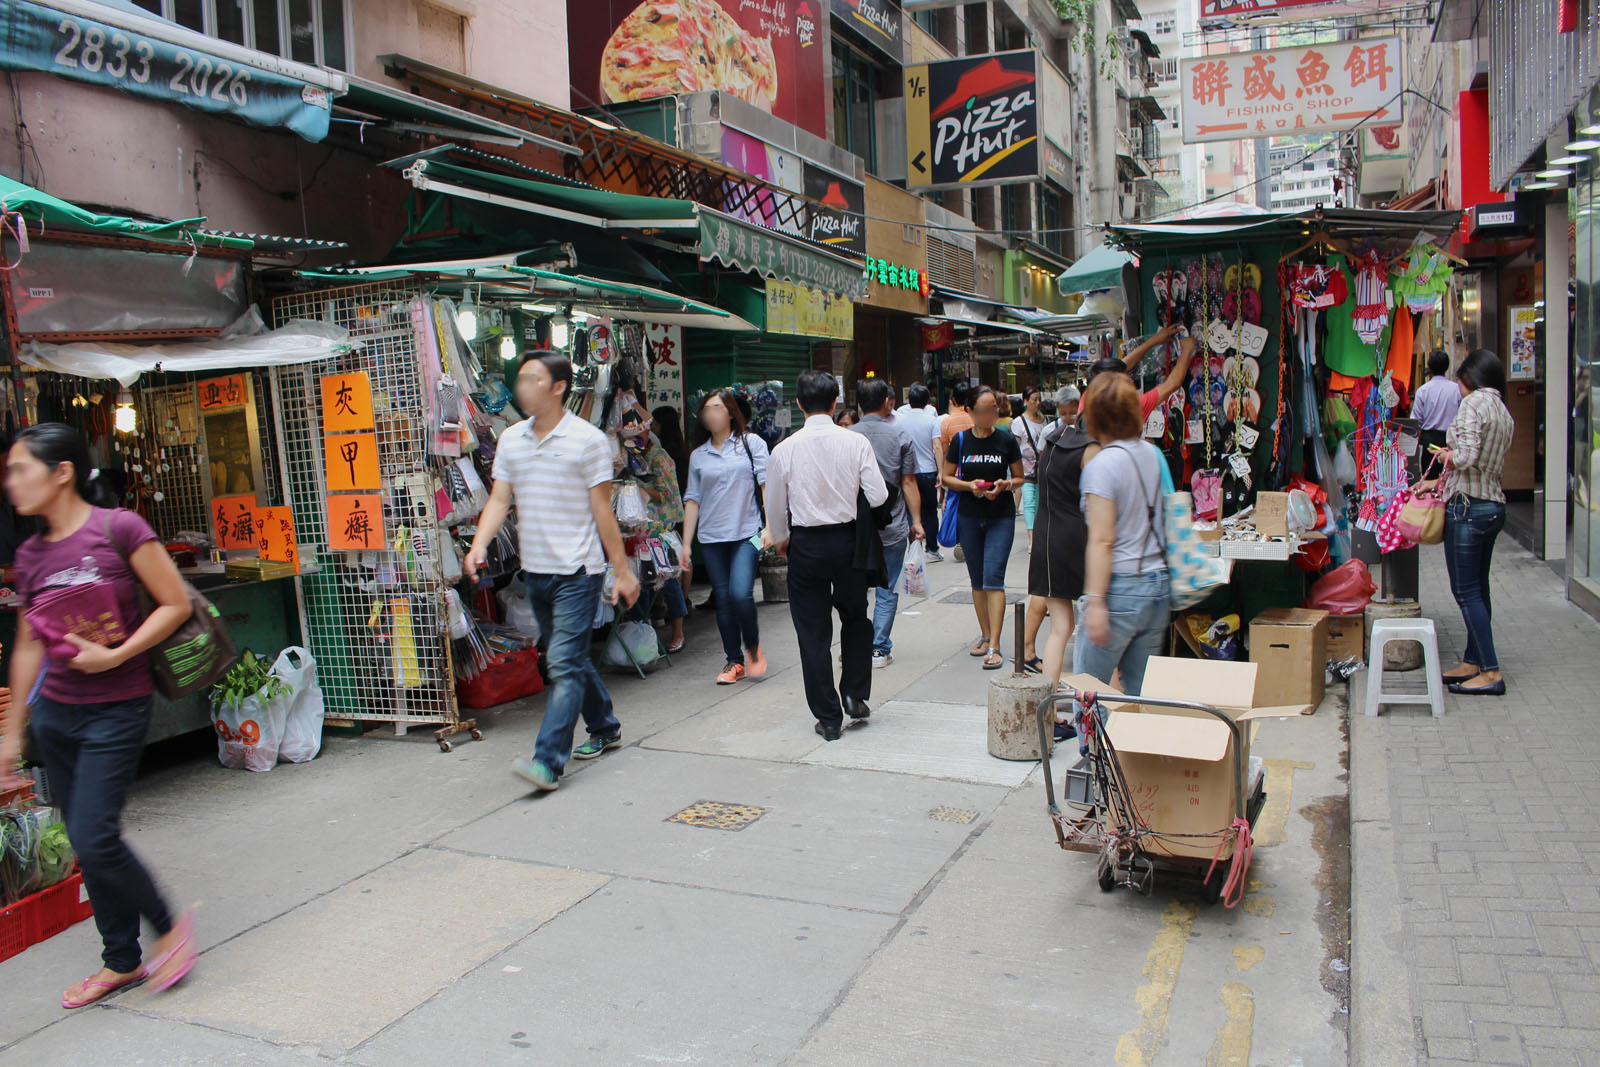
[272,283,458,733]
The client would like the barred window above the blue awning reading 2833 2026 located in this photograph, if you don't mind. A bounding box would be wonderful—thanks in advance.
[133,0,350,70]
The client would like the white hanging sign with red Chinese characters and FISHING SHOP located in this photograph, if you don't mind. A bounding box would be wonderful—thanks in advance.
[1178,37,1405,144]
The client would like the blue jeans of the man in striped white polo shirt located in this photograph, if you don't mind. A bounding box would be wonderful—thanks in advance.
[528,571,622,777]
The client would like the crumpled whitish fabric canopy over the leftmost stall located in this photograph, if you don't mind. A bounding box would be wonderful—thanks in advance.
[18,318,352,386]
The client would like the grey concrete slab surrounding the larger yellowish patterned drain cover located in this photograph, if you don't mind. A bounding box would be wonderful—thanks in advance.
[442,748,1005,912]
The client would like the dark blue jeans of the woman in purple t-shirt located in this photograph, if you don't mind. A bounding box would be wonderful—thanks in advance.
[32,696,173,974]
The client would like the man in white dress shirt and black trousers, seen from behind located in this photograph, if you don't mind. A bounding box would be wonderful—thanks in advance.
[766,371,888,741]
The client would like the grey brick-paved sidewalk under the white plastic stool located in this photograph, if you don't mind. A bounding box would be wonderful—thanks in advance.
[1350,537,1600,1064]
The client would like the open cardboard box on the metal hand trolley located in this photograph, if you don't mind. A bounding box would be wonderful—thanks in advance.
[1100,656,1306,859]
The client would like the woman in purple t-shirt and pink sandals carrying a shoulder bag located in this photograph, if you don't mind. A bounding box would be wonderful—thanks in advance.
[0,422,195,1008]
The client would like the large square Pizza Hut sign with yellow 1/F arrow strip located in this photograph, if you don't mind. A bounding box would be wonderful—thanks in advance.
[906,51,1042,189]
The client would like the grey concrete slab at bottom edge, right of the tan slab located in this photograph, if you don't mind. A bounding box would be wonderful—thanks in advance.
[352,878,896,1067]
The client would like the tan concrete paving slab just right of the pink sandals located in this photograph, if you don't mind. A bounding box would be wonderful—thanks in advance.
[131,849,605,1054]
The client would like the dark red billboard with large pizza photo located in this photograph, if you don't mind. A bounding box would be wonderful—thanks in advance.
[566,0,829,136]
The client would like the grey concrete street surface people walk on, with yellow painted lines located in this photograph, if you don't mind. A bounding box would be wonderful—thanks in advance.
[0,537,1347,1067]
